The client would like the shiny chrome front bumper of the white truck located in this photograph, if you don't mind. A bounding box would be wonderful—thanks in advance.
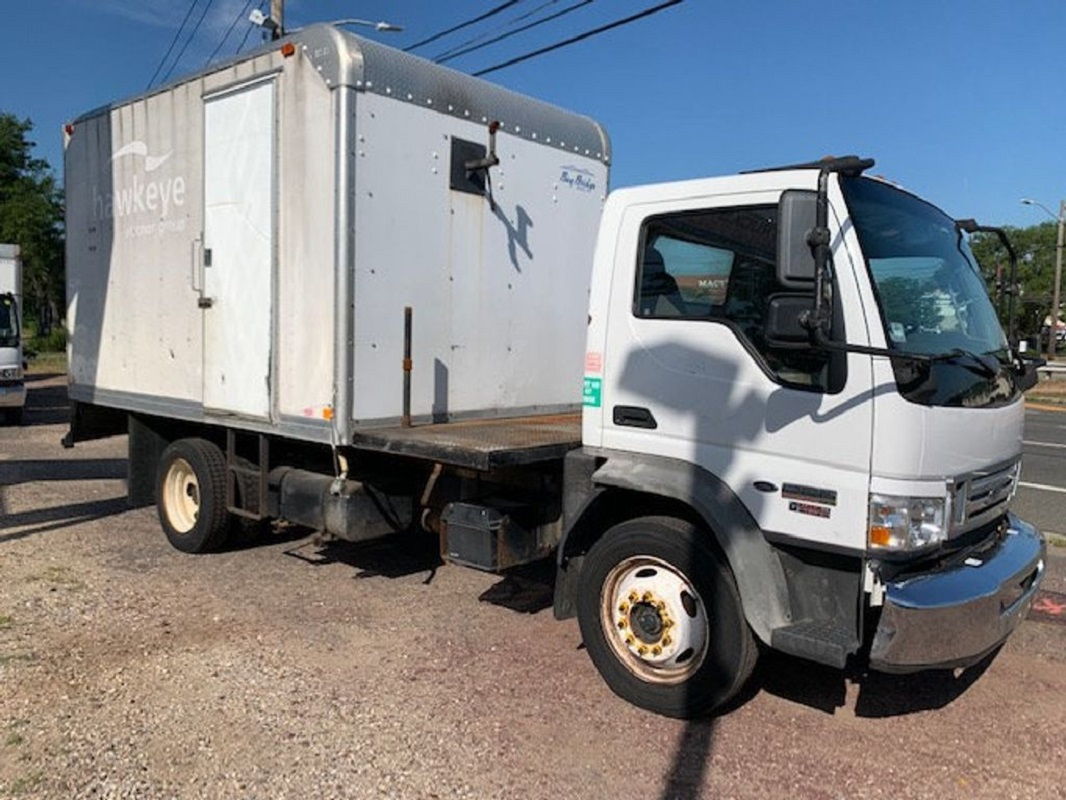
[870,514,1047,672]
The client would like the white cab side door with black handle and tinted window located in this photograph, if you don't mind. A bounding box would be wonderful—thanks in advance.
[601,192,873,551]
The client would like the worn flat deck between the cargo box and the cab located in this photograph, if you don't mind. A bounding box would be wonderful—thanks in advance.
[352,413,581,470]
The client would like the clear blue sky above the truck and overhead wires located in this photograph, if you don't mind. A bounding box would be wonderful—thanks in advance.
[0,0,1066,225]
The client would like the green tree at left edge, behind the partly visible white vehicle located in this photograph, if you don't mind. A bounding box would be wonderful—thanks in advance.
[0,112,65,334]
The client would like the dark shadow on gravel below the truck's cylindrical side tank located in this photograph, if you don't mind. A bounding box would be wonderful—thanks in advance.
[285,531,441,583]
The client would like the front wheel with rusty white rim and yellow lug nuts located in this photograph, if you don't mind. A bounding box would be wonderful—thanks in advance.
[578,516,758,719]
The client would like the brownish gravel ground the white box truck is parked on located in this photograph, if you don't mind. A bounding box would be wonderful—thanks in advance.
[0,378,1066,800]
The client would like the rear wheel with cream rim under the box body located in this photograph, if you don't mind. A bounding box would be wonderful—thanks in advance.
[156,438,229,553]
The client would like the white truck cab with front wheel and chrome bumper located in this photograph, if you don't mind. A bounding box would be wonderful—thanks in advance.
[556,160,1045,716]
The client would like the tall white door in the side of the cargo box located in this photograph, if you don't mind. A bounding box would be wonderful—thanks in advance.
[199,80,274,417]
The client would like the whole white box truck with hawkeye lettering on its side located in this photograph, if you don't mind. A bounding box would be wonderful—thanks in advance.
[65,26,1045,717]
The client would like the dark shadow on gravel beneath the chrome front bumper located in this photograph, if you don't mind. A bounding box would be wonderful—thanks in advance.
[753,651,998,718]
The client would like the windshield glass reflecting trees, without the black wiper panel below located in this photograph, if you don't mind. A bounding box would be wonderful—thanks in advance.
[842,178,1008,357]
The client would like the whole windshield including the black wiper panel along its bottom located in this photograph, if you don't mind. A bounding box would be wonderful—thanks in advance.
[840,178,1018,406]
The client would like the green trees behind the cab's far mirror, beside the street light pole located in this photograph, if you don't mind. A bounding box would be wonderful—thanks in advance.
[970,221,1057,337]
